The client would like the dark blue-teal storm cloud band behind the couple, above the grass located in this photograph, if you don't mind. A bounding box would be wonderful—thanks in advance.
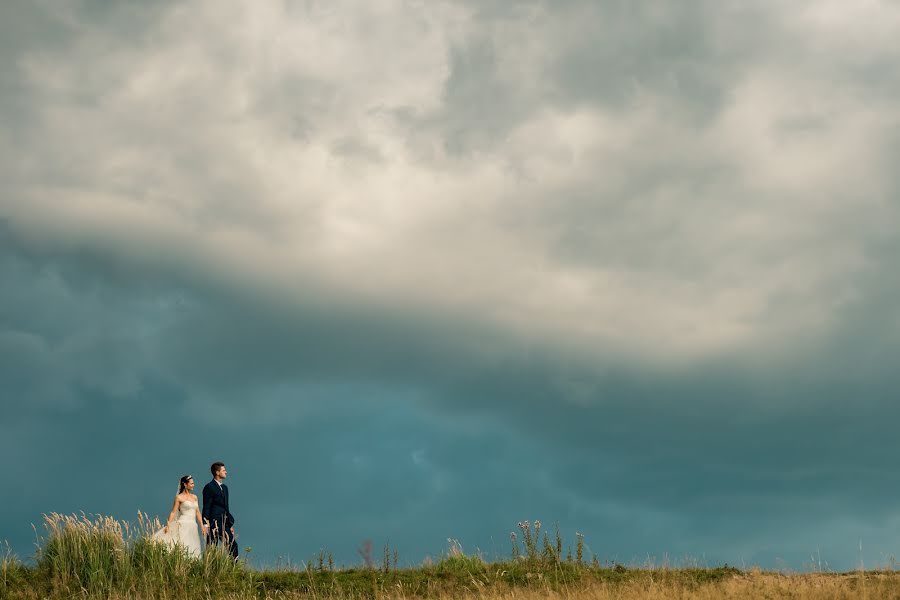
[3,221,898,567]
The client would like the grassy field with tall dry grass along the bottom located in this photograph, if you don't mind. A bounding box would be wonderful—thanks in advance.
[0,515,900,600]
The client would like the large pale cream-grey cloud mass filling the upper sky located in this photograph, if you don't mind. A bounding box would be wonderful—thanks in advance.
[0,2,900,362]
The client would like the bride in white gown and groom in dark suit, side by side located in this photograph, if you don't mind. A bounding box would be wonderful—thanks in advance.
[153,462,237,560]
